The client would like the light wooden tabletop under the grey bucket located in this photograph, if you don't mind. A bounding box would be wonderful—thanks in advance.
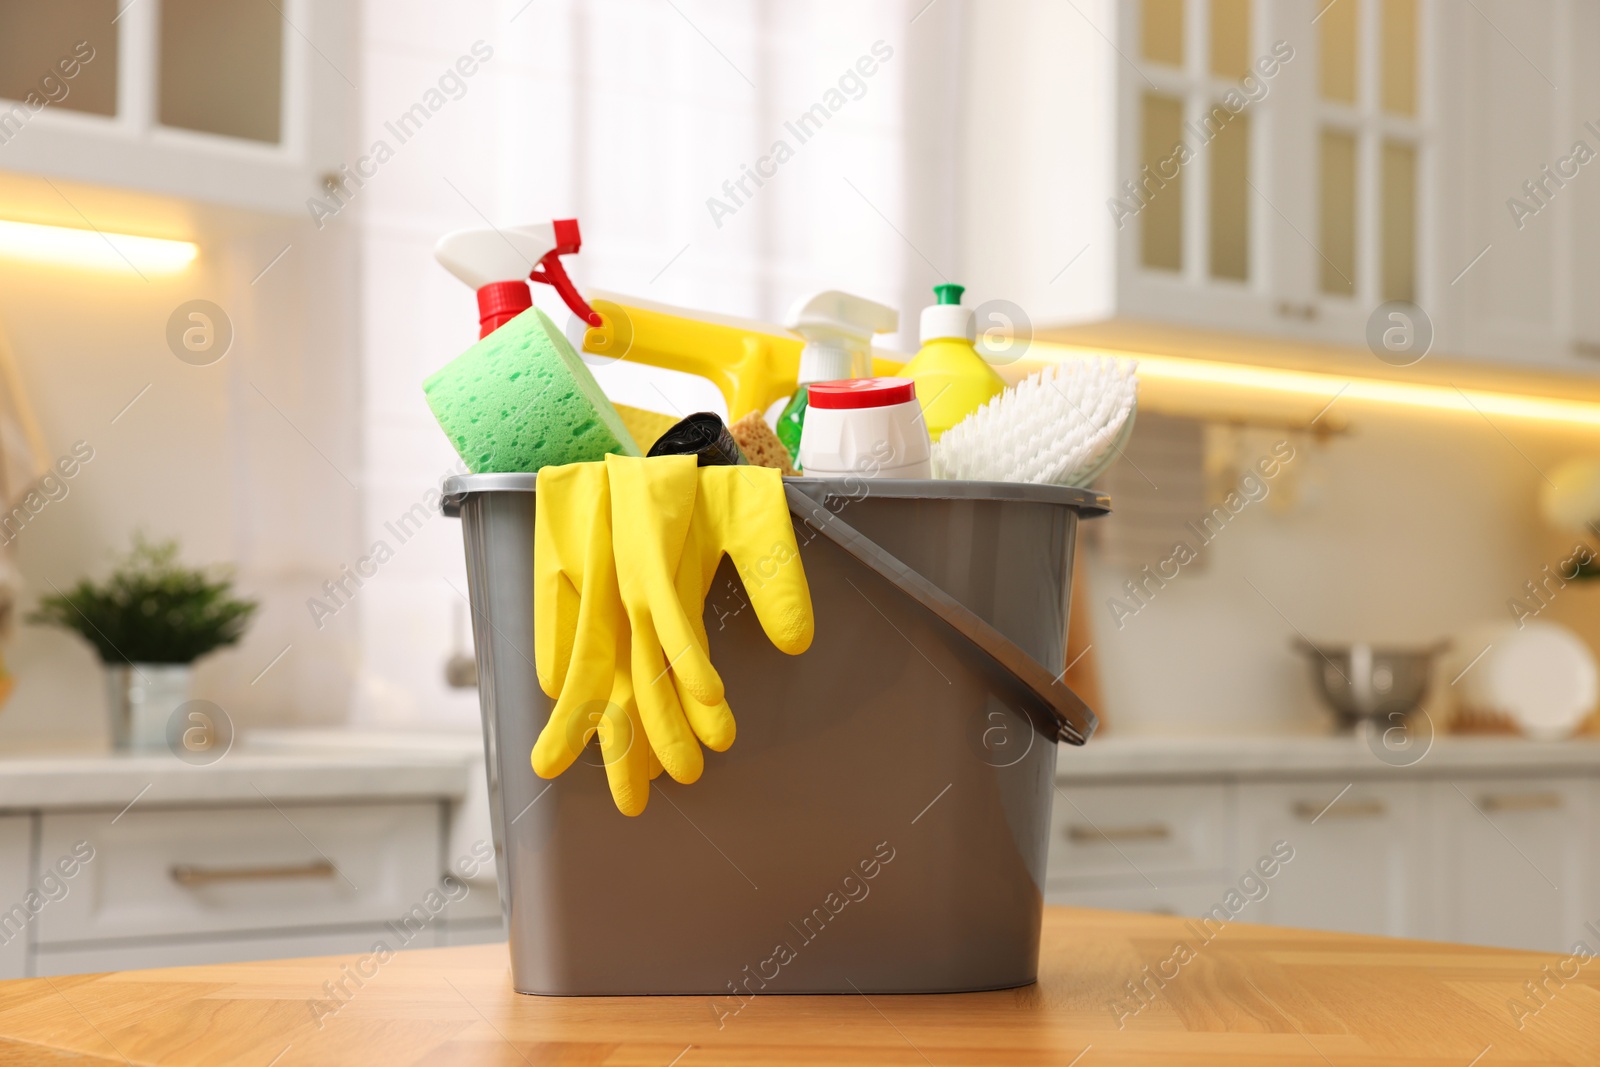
[0,909,1600,1067]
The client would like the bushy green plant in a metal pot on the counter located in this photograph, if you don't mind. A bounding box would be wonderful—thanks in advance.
[29,534,258,749]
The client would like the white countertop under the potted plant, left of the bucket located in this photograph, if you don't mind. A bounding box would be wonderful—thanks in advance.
[0,731,483,811]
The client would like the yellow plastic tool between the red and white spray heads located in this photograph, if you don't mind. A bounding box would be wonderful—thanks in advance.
[584,294,901,421]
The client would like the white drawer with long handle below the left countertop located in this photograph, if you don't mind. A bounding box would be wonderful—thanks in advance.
[38,803,443,944]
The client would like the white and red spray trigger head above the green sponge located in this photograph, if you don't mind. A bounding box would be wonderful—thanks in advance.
[434,219,600,339]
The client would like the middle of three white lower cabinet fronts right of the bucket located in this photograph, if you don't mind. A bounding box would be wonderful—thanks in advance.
[1235,779,1427,937]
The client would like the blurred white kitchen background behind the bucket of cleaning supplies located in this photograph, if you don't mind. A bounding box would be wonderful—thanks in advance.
[0,0,1600,974]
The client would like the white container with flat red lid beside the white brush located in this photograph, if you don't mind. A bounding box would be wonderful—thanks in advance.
[800,378,933,478]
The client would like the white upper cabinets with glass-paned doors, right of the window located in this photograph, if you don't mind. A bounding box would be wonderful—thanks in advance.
[962,0,1600,371]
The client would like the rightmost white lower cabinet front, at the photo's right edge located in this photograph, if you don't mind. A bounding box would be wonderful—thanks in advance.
[1432,777,1594,952]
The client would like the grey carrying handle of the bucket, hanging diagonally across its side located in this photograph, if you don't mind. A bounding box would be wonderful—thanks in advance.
[784,483,1099,745]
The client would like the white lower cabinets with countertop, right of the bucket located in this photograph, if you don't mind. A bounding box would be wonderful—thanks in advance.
[1043,734,1600,953]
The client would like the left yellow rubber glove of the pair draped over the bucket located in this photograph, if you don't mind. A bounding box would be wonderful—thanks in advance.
[531,462,661,816]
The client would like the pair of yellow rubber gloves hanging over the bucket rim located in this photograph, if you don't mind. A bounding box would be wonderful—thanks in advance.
[533,456,813,814]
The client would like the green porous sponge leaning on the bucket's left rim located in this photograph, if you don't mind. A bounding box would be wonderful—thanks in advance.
[422,307,642,474]
